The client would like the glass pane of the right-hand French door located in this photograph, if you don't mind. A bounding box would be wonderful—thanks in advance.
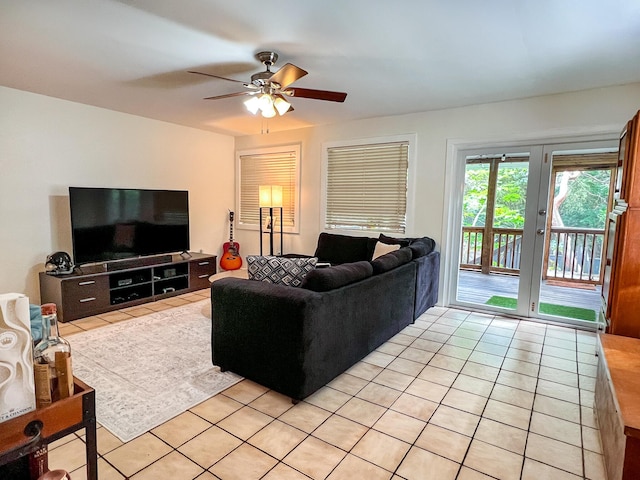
[538,152,617,322]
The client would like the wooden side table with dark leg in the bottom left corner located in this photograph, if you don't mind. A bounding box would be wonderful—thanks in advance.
[0,378,98,480]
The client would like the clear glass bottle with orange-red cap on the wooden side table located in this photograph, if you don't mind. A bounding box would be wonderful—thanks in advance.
[33,303,73,408]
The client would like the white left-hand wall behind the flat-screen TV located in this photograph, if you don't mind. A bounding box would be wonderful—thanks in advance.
[0,87,234,303]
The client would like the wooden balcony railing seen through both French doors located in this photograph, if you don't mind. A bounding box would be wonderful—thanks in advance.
[460,227,604,284]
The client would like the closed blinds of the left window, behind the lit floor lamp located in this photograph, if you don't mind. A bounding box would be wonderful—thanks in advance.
[237,145,300,233]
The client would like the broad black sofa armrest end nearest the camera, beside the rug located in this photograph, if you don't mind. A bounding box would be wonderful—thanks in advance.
[211,278,320,399]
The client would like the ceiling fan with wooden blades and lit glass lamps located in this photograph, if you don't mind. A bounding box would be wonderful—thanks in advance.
[189,52,347,118]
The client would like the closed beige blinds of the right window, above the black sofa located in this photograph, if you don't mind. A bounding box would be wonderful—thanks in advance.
[325,142,409,233]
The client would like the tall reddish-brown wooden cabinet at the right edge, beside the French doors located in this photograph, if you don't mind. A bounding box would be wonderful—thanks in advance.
[602,112,640,338]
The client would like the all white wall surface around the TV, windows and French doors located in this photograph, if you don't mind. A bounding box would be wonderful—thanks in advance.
[5,80,640,302]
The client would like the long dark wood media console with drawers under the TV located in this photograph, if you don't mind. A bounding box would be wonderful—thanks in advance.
[40,253,216,322]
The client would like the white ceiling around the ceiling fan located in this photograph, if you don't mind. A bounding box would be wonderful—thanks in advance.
[0,0,640,135]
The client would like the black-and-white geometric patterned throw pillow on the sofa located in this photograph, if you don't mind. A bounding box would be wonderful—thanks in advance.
[247,255,318,287]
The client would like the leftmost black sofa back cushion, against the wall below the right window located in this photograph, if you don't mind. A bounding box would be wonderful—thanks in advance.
[314,232,378,265]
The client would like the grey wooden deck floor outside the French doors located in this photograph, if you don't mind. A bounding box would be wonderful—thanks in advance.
[457,270,601,312]
